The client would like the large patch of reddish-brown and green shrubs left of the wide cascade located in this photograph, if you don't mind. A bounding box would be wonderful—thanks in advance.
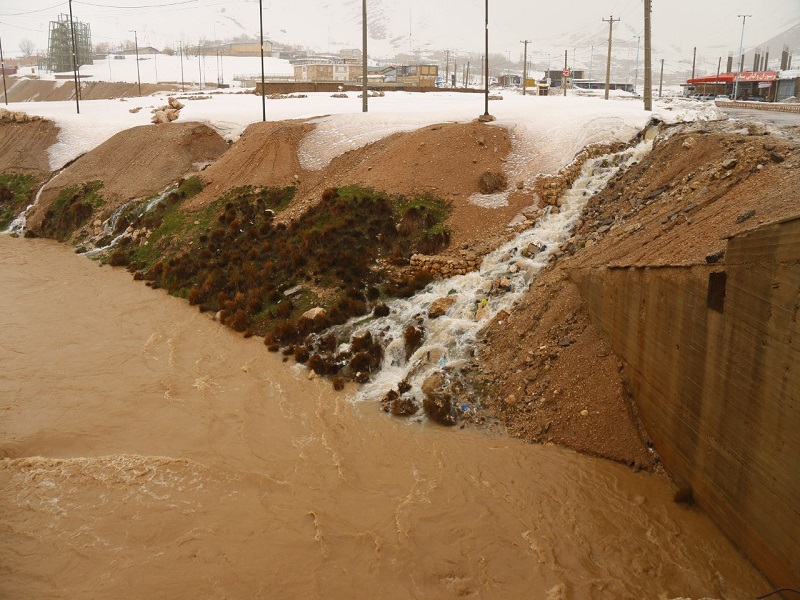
[104,186,450,377]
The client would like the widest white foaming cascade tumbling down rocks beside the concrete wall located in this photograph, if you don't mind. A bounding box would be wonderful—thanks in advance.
[326,132,652,401]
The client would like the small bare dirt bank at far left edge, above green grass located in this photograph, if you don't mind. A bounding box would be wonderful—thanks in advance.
[0,120,58,179]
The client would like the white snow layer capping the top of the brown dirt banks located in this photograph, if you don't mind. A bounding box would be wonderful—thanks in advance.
[4,68,723,173]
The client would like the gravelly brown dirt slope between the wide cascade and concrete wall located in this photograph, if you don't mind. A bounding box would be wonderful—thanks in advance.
[474,116,800,467]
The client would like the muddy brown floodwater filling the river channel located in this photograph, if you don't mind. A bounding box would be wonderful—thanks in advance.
[0,236,769,599]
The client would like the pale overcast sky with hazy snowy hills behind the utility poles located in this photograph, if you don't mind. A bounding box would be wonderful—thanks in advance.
[0,0,800,65]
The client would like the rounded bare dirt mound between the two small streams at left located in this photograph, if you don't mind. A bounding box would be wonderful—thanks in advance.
[28,123,228,231]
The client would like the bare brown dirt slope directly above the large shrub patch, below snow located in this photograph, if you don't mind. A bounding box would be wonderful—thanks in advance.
[189,121,533,252]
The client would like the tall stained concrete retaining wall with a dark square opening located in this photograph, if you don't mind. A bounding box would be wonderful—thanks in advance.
[571,219,800,588]
